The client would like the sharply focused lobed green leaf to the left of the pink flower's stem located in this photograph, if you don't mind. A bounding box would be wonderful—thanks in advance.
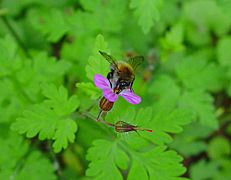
[11,84,79,152]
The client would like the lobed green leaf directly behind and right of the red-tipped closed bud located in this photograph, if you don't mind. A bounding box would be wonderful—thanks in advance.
[110,107,193,145]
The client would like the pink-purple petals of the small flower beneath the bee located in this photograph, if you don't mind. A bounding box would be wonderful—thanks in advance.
[94,74,141,104]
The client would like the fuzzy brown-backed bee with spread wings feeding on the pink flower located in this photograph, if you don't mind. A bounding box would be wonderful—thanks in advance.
[99,51,144,94]
